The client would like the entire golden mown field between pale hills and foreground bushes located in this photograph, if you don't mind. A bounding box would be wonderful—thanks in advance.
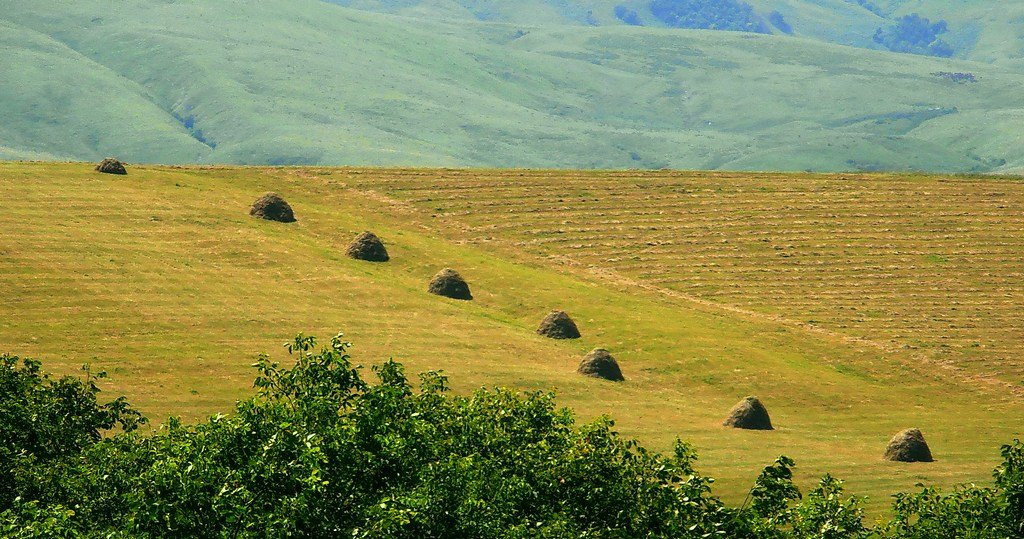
[0,163,1024,512]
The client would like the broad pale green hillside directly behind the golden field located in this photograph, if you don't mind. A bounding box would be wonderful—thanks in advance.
[0,0,1024,171]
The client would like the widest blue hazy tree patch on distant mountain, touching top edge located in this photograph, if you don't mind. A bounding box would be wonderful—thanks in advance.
[650,0,770,34]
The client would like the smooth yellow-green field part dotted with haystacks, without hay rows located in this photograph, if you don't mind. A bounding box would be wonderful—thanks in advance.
[0,163,1022,513]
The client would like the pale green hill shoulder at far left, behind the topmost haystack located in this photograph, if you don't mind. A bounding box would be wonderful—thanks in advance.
[0,19,209,161]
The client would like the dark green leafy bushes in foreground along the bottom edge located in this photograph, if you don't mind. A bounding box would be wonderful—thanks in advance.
[0,335,1024,539]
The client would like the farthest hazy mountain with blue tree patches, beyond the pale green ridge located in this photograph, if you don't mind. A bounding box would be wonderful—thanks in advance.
[326,0,1024,66]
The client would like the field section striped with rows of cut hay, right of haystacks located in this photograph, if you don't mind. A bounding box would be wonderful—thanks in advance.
[356,171,1024,385]
